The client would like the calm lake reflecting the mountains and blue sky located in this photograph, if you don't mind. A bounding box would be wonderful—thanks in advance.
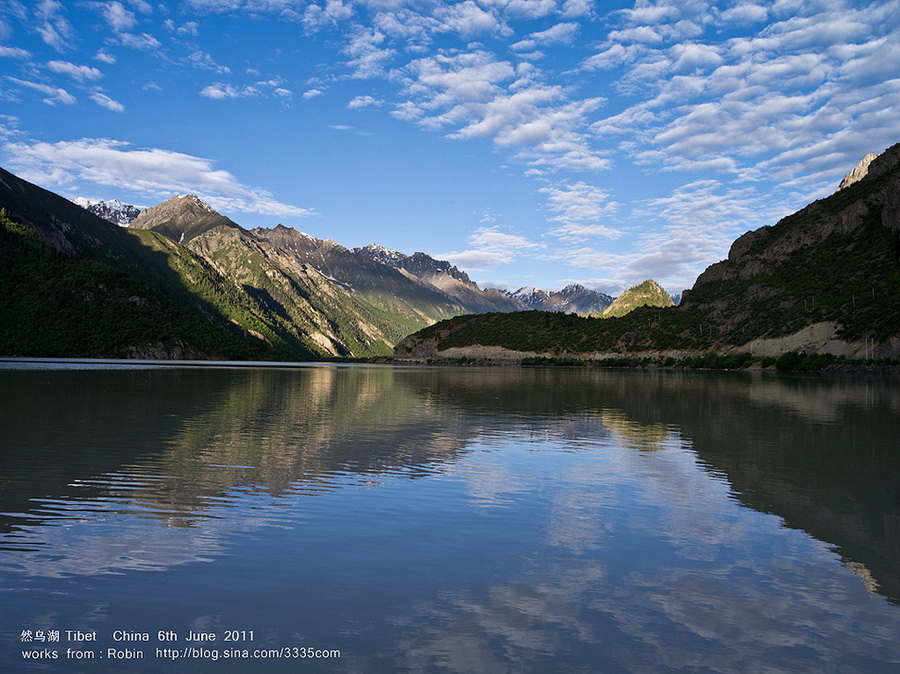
[0,362,900,674]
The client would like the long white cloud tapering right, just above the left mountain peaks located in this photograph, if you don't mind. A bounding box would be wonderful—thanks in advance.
[4,138,313,217]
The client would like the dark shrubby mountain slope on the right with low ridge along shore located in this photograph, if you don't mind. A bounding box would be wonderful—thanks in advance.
[395,145,900,359]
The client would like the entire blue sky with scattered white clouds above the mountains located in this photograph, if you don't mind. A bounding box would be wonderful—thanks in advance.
[0,0,900,295]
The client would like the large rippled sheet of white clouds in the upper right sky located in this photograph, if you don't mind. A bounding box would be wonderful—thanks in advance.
[582,0,900,189]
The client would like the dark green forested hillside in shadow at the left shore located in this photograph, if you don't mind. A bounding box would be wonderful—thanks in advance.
[0,216,292,359]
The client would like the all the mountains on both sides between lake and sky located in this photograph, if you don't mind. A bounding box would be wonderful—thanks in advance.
[0,139,900,364]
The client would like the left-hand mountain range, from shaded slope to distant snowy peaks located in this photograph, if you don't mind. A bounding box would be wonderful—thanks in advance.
[0,169,612,359]
